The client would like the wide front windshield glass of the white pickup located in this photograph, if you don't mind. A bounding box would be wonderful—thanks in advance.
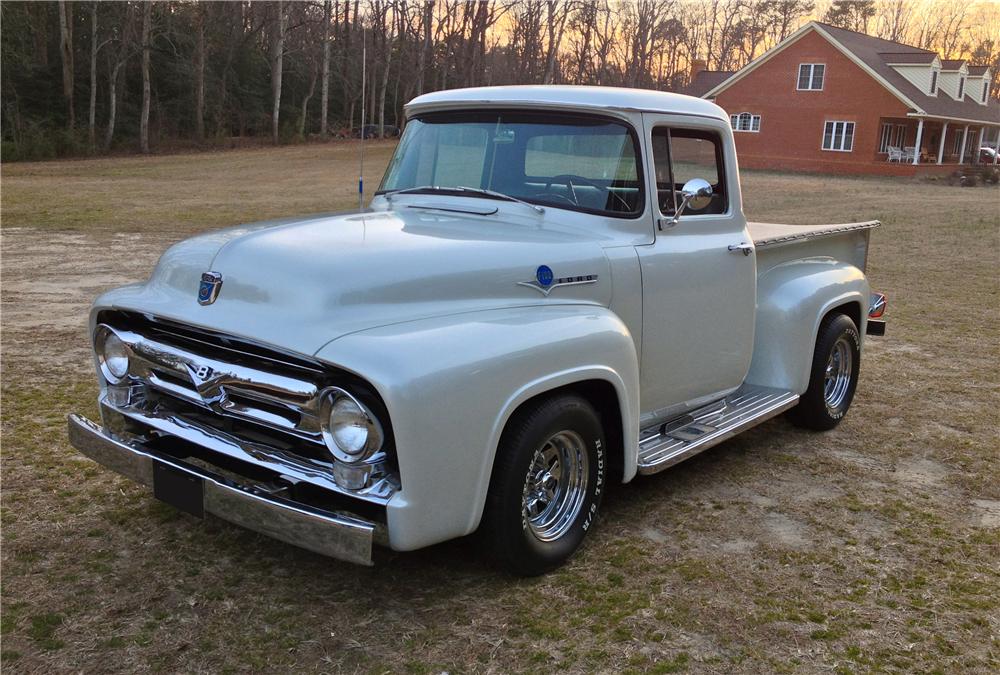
[376,112,643,217]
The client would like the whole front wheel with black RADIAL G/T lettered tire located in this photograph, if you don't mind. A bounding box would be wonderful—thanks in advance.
[483,395,608,576]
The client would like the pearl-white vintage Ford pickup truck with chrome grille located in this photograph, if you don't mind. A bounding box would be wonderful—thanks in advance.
[69,87,885,574]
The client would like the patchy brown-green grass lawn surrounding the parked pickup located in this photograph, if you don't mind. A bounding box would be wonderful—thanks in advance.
[0,142,1000,673]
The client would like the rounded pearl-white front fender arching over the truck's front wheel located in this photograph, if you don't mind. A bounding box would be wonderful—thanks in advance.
[316,305,639,550]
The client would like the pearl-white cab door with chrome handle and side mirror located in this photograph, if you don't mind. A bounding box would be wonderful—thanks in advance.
[636,114,757,422]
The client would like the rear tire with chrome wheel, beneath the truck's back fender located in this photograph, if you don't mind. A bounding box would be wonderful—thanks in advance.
[791,314,861,431]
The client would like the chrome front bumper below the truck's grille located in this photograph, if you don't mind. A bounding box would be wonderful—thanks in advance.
[69,415,375,565]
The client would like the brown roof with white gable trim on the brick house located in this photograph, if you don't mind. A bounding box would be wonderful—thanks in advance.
[704,21,1000,124]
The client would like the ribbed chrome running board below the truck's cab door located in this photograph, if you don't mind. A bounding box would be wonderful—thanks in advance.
[639,385,799,474]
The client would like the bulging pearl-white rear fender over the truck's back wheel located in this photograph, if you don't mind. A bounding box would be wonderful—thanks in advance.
[746,258,869,394]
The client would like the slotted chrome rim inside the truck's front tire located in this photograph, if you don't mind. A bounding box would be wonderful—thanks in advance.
[521,431,590,541]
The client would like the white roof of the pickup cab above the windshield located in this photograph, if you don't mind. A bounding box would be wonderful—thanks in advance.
[405,85,729,122]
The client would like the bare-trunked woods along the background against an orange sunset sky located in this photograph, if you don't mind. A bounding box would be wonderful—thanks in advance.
[0,0,1000,160]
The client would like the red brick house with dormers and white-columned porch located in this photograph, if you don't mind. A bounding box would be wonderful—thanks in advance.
[688,21,1000,175]
